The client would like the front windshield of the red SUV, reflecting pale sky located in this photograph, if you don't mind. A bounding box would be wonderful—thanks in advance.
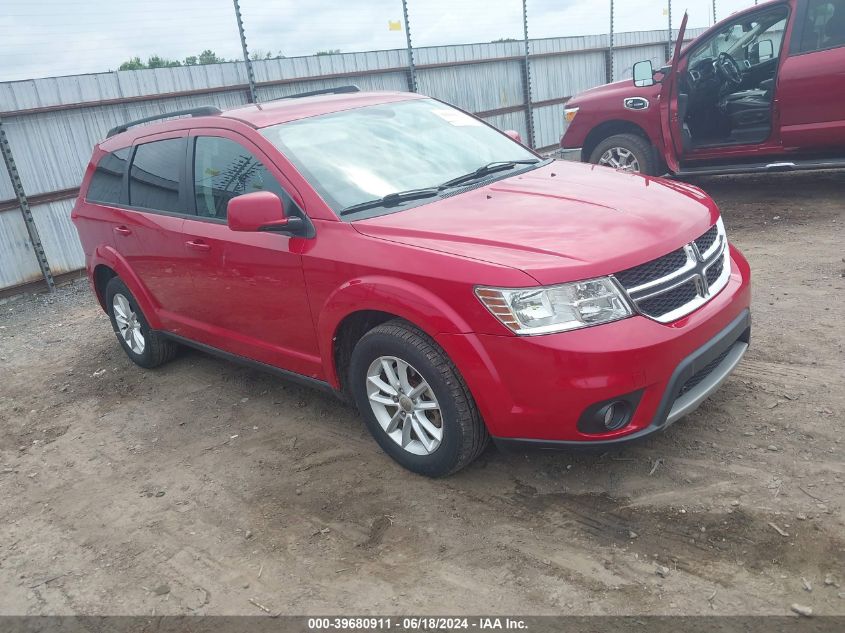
[261,99,537,219]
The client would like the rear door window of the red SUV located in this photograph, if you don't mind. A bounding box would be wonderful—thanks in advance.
[129,137,188,213]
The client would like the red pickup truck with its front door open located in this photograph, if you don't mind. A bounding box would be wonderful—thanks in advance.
[560,0,845,176]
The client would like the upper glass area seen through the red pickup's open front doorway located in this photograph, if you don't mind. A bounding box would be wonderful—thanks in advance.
[689,7,788,68]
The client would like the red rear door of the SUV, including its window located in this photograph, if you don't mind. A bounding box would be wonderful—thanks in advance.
[112,131,193,336]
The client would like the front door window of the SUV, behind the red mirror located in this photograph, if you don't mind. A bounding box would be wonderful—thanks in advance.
[194,136,298,220]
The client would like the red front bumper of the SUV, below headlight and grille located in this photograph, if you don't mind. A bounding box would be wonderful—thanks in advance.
[436,247,751,448]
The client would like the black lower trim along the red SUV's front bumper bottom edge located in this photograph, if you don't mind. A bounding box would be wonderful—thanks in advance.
[492,308,751,451]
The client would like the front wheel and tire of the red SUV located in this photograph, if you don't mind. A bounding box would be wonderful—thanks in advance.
[348,320,490,477]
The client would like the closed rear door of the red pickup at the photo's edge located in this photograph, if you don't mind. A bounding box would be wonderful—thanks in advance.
[777,0,845,152]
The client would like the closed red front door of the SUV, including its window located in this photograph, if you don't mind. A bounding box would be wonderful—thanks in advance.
[184,130,322,378]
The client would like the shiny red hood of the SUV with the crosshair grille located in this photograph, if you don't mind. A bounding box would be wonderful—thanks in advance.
[352,161,719,284]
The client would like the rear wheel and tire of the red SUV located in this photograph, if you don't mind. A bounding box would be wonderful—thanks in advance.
[106,277,179,369]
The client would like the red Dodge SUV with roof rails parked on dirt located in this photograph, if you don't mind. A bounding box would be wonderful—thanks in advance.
[73,87,750,476]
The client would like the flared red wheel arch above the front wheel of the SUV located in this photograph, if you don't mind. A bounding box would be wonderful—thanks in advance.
[315,275,471,388]
